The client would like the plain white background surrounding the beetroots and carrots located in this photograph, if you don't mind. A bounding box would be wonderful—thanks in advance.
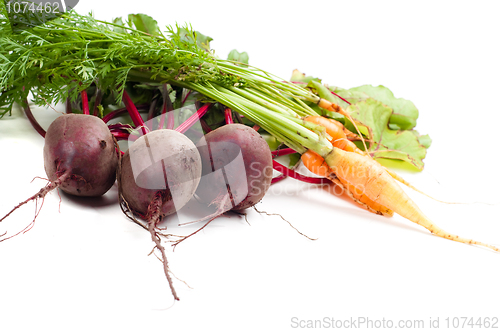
[0,0,500,331]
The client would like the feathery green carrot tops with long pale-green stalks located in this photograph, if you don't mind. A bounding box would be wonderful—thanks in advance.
[0,11,425,169]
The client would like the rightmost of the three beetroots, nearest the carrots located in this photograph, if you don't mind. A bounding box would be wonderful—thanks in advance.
[196,124,273,211]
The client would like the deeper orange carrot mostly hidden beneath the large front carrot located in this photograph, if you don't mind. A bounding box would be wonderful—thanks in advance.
[301,150,394,217]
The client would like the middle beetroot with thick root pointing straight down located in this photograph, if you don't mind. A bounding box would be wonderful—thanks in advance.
[119,129,201,300]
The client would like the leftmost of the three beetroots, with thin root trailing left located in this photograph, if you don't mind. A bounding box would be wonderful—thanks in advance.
[0,114,118,241]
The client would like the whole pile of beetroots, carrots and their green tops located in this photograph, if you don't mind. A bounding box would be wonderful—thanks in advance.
[0,12,500,299]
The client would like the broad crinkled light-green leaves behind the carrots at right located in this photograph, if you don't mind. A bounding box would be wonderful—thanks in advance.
[292,71,431,170]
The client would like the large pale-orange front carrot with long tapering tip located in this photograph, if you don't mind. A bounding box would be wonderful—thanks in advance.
[318,147,500,252]
